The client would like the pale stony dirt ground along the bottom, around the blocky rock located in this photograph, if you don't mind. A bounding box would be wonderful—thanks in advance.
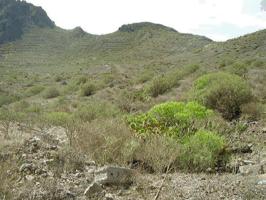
[0,124,266,200]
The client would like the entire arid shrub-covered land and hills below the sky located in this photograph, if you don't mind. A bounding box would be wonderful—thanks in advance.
[0,0,266,200]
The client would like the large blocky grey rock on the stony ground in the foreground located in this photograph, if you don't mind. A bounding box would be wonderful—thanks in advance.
[95,166,133,185]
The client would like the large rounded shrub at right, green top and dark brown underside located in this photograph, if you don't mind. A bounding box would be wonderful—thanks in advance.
[189,72,252,120]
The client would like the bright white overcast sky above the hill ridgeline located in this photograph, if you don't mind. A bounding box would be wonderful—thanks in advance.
[27,0,266,41]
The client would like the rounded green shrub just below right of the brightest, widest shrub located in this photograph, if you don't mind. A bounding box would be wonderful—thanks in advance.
[178,130,225,171]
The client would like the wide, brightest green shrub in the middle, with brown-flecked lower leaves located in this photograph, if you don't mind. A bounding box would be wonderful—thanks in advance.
[127,102,212,139]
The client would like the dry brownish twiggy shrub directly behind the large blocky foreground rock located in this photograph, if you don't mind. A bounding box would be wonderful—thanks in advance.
[75,120,134,164]
